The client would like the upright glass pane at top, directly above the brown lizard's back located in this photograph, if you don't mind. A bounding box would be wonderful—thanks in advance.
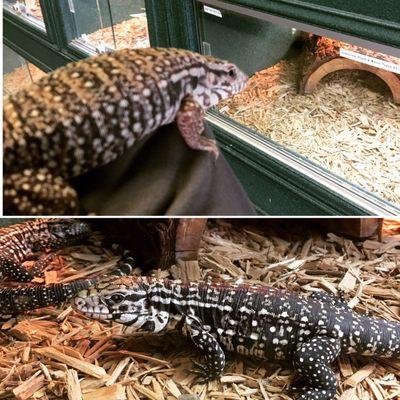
[65,0,150,52]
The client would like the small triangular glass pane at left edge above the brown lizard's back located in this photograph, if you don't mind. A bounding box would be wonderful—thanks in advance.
[3,45,45,95]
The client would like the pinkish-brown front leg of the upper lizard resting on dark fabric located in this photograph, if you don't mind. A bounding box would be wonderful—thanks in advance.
[176,96,219,158]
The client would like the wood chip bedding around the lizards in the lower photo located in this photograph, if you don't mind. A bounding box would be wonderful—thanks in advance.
[0,220,400,400]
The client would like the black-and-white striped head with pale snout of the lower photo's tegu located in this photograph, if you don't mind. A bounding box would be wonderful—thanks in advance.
[71,276,168,332]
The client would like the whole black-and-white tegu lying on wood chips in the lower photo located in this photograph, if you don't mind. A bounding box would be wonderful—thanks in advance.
[71,276,400,400]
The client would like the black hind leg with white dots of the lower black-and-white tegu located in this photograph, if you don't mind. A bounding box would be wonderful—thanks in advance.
[293,336,341,400]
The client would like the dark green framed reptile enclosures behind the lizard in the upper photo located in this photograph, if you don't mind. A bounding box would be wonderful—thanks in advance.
[4,0,400,215]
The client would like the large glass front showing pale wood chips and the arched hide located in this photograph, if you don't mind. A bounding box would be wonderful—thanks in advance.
[198,2,400,205]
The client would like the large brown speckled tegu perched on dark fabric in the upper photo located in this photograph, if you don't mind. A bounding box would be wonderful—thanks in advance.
[4,48,247,214]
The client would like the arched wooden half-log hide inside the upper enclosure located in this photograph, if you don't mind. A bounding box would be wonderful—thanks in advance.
[299,35,400,104]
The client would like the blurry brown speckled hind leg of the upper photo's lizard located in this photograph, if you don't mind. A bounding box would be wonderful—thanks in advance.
[3,168,78,215]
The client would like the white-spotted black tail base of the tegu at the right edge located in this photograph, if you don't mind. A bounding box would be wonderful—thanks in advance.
[350,316,400,358]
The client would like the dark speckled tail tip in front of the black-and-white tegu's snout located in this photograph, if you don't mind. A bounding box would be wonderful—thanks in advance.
[0,279,97,315]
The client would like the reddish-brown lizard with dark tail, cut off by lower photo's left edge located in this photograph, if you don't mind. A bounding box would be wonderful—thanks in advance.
[0,218,97,315]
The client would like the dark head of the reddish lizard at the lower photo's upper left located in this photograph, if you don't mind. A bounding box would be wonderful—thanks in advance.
[34,218,90,250]
